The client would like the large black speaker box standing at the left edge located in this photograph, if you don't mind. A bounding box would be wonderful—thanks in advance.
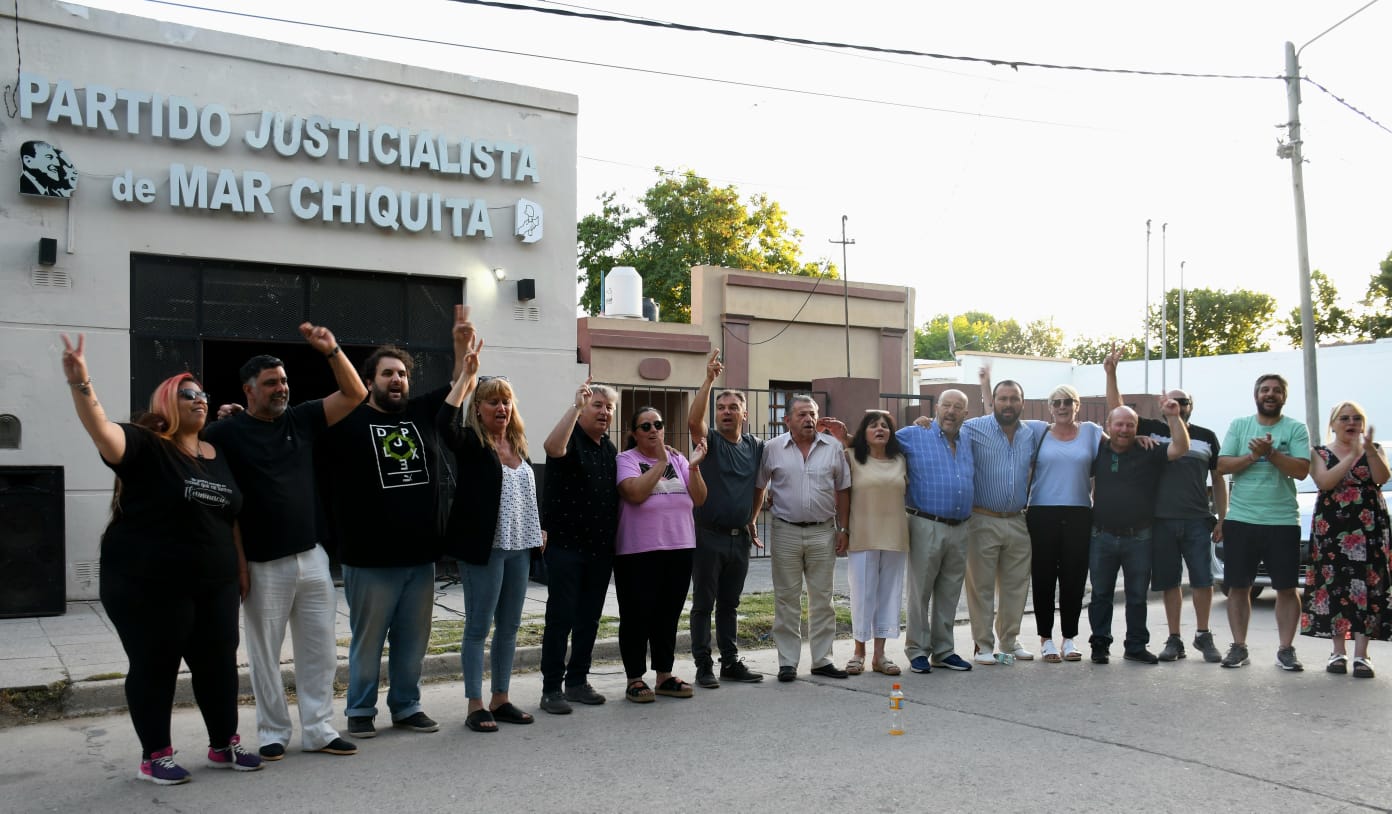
[0,466,67,618]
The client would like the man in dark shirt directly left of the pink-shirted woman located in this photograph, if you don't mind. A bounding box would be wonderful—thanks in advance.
[540,380,618,715]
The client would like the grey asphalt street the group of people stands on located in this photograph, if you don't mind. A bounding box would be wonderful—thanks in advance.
[0,600,1392,813]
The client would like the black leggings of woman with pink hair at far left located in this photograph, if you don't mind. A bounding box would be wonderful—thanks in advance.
[100,573,241,758]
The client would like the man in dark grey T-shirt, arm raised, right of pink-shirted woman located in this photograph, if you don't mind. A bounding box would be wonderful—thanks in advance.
[686,351,764,689]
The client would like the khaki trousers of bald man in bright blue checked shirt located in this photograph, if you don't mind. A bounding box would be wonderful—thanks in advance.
[903,515,976,661]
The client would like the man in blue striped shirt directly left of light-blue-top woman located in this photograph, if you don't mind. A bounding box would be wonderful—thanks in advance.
[962,367,1038,665]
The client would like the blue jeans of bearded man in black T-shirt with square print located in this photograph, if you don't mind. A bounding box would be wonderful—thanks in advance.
[342,562,434,721]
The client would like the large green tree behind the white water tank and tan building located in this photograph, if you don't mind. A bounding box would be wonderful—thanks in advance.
[576,167,838,323]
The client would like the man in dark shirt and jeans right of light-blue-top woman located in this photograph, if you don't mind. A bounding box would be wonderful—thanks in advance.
[1087,398,1189,664]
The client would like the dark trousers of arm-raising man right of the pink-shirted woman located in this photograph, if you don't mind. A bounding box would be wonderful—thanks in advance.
[690,526,749,667]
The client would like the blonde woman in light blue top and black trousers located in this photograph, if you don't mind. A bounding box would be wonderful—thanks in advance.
[1025,384,1104,662]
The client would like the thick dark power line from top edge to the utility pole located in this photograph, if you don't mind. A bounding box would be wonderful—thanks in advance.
[451,0,1283,79]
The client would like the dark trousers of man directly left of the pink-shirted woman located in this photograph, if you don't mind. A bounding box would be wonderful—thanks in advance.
[541,545,614,693]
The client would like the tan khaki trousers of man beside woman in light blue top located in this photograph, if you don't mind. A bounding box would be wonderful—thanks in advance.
[966,515,1030,653]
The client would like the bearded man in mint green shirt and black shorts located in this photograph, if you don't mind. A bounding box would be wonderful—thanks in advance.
[1218,373,1310,672]
